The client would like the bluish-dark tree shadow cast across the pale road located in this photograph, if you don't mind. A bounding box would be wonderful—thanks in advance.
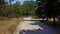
[19,21,60,34]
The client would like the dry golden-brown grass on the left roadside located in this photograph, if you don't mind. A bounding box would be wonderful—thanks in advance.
[0,18,19,34]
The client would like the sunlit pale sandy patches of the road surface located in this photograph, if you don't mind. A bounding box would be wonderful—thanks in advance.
[14,17,43,34]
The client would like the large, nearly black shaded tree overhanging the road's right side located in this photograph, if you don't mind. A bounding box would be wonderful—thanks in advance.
[35,0,60,24]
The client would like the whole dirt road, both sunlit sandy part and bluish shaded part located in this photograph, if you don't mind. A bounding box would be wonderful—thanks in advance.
[14,17,58,34]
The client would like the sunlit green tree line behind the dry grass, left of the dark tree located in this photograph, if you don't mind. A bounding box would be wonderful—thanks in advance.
[0,0,35,17]
